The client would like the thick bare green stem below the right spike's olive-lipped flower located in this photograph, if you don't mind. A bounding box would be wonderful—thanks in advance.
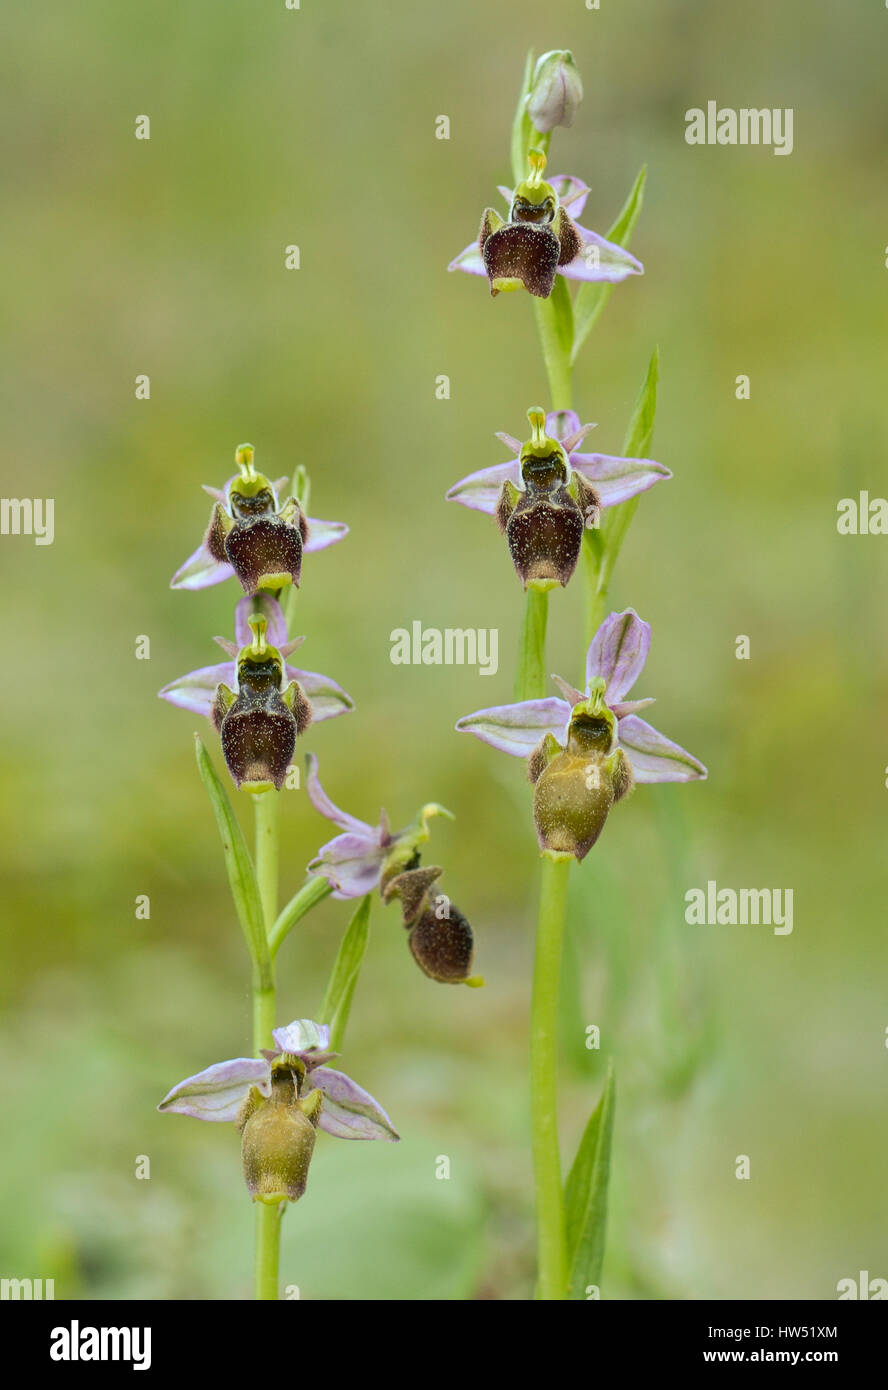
[531,855,570,1301]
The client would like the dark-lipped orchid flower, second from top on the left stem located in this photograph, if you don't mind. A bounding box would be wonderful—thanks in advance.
[160,595,353,792]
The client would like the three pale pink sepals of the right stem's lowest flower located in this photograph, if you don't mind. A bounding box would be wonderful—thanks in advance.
[456,609,707,783]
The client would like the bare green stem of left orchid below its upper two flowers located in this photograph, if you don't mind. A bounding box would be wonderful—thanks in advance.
[253,791,279,1301]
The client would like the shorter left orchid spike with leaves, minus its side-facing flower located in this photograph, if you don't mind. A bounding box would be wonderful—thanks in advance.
[158,445,397,1301]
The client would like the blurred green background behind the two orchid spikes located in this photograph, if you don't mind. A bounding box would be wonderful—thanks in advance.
[0,0,888,1300]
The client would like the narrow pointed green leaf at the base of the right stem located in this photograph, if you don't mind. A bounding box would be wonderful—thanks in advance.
[564,1065,616,1300]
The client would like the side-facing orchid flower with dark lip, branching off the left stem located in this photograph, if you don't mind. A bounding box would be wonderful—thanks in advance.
[306,753,484,986]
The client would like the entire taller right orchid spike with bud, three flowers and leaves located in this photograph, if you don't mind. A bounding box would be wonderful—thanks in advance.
[447,50,672,1300]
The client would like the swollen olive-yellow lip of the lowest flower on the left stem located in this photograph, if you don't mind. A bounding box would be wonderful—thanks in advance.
[242,1068,322,1205]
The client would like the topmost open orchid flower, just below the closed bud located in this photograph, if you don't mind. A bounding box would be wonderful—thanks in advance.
[447,150,645,299]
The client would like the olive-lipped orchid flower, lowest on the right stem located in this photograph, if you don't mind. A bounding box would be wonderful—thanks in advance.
[456,609,706,860]
